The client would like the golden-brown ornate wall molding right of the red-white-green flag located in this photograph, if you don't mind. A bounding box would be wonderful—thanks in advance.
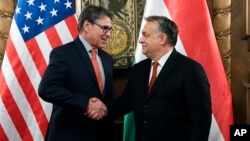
[213,0,231,84]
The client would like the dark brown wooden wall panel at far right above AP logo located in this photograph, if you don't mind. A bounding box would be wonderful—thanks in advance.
[231,0,250,123]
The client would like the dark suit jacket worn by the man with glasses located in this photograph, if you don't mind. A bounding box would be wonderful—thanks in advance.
[38,38,114,141]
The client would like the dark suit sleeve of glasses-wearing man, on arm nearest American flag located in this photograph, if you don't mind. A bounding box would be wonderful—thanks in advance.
[38,47,88,115]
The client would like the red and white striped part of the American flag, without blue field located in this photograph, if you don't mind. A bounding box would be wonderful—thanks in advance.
[0,12,78,141]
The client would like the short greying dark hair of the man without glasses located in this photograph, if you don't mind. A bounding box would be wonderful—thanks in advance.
[145,16,178,46]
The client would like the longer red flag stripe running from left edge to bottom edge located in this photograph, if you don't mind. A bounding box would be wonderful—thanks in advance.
[0,73,33,140]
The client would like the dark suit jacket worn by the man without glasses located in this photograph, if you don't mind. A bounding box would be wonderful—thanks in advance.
[108,50,211,141]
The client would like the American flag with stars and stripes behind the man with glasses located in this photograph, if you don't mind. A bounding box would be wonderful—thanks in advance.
[0,0,78,141]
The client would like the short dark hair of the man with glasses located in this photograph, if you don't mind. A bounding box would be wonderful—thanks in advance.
[78,5,113,31]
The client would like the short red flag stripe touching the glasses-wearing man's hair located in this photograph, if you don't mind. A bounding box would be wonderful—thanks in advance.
[64,15,78,38]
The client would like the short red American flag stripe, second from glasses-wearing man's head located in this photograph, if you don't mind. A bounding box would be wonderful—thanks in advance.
[45,26,62,48]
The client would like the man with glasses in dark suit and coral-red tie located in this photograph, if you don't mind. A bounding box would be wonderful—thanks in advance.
[38,5,114,141]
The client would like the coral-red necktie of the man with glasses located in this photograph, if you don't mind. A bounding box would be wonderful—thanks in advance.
[91,49,103,93]
